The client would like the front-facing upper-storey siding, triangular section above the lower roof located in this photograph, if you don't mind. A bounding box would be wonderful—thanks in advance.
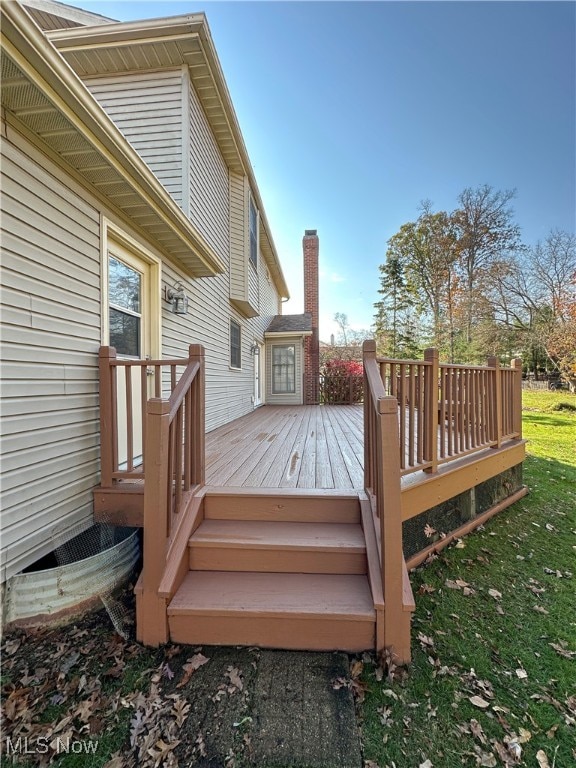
[85,69,183,206]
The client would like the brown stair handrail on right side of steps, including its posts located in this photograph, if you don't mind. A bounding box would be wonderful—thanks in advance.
[364,341,416,663]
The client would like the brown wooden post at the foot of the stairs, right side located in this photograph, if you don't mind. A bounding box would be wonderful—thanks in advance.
[377,397,410,662]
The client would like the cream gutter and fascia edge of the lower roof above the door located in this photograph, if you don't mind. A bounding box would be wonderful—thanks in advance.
[1,2,225,274]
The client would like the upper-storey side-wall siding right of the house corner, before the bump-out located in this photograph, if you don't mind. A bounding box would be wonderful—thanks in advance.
[188,74,230,266]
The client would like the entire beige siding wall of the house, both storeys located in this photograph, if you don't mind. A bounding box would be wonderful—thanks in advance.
[0,13,281,581]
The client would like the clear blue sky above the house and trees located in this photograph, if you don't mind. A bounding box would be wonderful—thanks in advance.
[56,0,576,340]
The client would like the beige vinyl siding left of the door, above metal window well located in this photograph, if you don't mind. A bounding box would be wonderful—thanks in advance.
[1,137,100,580]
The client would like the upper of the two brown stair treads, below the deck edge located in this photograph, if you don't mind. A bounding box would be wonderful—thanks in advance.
[189,520,366,553]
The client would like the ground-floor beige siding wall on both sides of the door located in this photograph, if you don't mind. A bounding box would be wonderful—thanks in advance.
[1,99,279,581]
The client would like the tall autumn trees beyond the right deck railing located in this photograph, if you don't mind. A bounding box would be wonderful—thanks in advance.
[373,185,576,380]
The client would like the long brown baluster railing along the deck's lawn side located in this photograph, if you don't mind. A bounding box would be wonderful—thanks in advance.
[377,349,522,475]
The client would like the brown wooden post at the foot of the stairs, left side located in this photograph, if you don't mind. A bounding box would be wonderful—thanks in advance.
[140,398,172,647]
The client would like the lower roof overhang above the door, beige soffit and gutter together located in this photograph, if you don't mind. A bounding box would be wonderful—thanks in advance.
[0,2,225,277]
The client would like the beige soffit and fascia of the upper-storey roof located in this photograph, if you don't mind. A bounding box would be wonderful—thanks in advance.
[47,13,289,298]
